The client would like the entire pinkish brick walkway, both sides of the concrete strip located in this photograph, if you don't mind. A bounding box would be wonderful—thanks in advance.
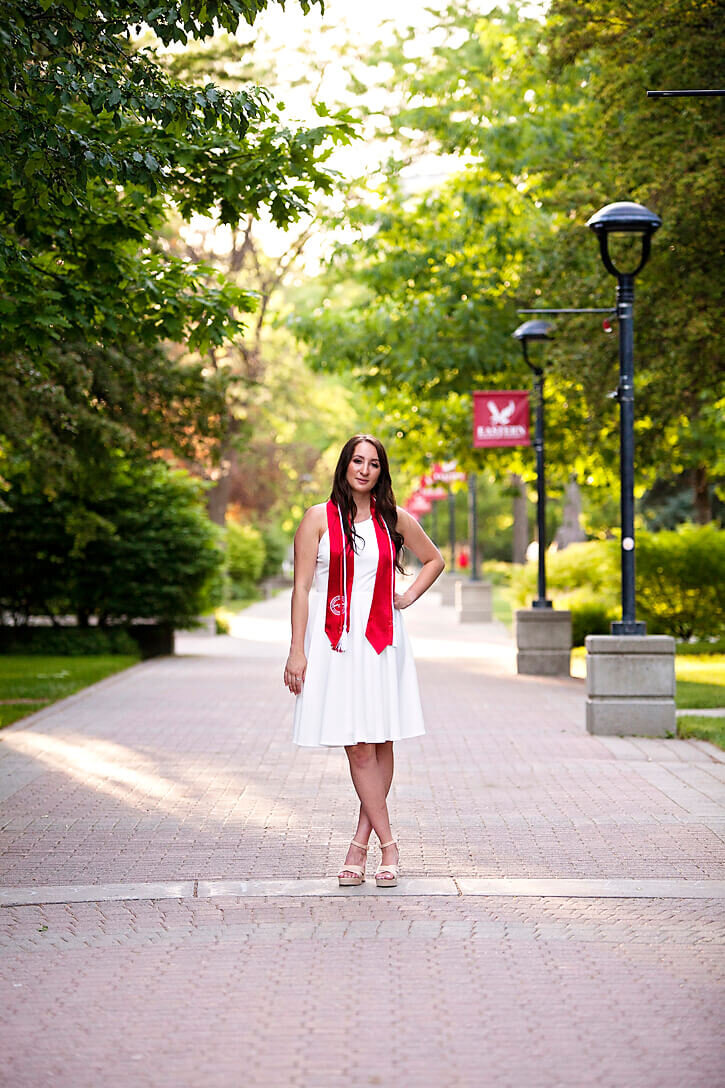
[0,593,725,1088]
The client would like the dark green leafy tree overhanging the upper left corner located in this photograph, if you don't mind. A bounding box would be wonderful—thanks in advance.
[0,0,352,484]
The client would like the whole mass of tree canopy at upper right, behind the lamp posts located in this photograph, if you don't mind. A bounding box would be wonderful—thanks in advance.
[289,0,725,514]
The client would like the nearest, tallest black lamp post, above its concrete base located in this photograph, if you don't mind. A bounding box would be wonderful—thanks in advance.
[587,201,662,634]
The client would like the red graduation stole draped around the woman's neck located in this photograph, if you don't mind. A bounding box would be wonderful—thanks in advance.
[324,499,395,654]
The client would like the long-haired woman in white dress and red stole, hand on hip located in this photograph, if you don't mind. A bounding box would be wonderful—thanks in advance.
[284,434,444,888]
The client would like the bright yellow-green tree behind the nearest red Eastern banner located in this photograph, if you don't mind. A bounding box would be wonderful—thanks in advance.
[293,4,594,482]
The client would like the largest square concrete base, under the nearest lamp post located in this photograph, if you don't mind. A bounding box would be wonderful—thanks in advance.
[587,634,676,737]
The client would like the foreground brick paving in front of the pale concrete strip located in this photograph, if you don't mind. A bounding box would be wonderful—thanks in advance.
[0,897,725,1088]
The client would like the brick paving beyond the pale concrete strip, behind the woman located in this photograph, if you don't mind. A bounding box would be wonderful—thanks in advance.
[0,601,725,886]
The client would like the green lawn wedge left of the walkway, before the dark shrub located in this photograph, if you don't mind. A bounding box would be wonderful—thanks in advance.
[0,654,138,727]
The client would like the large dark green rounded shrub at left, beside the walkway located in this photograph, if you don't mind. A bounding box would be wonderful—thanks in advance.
[0,453,223,627]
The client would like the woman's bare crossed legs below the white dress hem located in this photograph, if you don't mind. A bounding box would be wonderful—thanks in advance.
[343,741,397,873]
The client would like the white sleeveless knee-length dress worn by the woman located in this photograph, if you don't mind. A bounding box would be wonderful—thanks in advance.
[293,518,426,747]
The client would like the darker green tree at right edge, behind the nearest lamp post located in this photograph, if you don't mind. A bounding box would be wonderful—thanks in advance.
[528,0,725,521]
